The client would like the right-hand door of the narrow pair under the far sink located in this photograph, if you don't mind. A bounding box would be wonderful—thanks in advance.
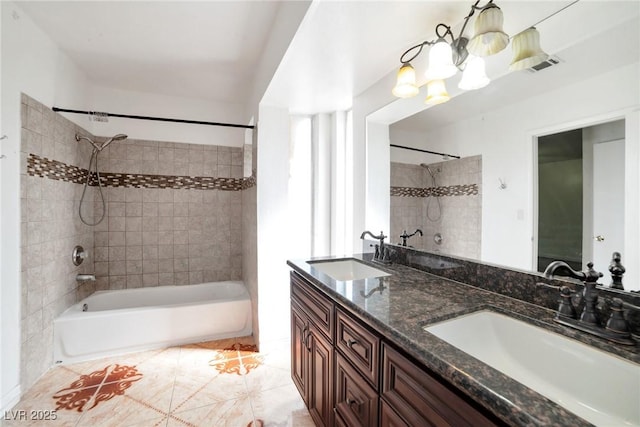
[307,324,333,426]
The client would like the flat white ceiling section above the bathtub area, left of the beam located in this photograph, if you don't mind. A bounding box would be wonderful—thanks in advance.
[18,1,280,102]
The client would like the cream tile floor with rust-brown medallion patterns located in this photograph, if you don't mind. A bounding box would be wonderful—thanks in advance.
[0,337,314,427]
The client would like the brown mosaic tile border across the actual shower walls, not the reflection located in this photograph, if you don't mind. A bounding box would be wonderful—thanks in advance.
[27,153,256,191]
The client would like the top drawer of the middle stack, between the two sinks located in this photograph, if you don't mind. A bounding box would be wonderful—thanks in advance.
[336,309,380,390]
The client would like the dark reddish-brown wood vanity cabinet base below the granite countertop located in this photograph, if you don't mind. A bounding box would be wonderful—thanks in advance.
[291,272,496,427]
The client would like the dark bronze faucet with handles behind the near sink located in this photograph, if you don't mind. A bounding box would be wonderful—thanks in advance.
[544,261,636,345]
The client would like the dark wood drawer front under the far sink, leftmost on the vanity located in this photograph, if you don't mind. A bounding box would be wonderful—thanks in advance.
[291,271,334,342]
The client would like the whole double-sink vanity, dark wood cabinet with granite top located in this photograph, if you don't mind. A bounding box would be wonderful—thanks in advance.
[288,247,640,427]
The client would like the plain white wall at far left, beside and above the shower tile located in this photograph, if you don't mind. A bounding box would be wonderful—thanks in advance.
[0,2,88,410]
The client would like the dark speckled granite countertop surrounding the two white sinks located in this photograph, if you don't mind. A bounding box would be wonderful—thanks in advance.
[287,255,640,426]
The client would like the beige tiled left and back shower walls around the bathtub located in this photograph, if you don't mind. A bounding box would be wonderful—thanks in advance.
[21,95,250,390]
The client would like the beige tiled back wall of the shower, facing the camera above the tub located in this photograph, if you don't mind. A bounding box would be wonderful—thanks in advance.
[92,139,243,289]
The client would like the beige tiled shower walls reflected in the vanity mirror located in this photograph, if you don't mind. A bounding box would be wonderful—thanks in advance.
[390,156,482,259]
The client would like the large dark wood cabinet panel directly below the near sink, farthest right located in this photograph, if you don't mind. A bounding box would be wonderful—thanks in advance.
[381,344,495,427]
